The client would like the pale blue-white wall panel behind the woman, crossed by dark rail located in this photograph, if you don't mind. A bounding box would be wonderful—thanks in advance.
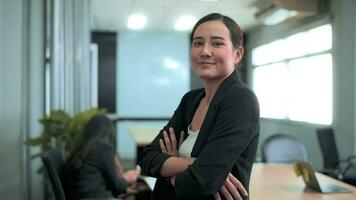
[116,32,190,159]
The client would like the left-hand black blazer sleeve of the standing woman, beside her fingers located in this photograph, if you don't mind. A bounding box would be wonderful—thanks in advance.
[139,93,189,177]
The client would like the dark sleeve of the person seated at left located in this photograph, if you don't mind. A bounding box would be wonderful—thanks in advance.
[98,145,129,196]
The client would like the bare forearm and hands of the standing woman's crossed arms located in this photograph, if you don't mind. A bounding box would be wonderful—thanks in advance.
[159,128,248,200]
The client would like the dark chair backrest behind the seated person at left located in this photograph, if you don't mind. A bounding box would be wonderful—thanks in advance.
[41,149,66,200]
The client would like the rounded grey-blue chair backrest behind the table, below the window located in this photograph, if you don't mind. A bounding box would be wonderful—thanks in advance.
[262,134,308,163]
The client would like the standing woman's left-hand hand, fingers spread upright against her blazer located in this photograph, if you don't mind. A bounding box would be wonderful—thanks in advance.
[159,127,184,157]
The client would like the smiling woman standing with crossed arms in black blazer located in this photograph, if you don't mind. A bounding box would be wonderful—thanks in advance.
[140,13,259,200]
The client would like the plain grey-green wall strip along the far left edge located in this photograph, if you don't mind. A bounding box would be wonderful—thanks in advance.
[0,0,24,199]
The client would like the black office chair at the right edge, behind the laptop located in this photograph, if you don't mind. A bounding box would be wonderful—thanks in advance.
[316,127,356,186]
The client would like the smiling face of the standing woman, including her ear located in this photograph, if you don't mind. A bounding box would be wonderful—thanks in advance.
[191,21,242,80]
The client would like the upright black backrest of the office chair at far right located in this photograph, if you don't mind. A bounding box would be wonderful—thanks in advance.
[316,127,339,170]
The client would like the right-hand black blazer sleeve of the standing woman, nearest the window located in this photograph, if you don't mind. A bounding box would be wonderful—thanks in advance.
[175,89,259,199]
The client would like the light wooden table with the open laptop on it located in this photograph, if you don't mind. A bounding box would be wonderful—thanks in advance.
[250,163,356,200]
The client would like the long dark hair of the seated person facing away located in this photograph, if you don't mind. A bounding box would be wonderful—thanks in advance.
[68,115,114,168]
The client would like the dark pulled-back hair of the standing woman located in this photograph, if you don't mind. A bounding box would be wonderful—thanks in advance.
[190,13,244,49]
